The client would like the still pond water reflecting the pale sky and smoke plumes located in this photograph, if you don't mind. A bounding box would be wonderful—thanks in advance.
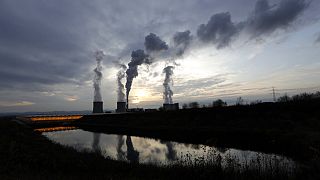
[42,129,296,172]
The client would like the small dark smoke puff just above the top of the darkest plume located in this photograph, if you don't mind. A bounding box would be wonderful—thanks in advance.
[144,33,168,52]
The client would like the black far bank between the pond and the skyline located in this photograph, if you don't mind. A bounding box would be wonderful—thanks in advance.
[72,99,320,161]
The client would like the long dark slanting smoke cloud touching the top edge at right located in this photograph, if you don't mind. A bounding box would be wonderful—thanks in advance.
[246,0,308,37]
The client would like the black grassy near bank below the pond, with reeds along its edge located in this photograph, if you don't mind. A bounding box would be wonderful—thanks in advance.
[0,118,315,179]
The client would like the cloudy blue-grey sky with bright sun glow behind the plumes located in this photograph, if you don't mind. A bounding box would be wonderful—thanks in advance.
[0,0,320,112]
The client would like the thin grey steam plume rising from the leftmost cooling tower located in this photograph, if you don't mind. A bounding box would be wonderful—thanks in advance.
[93,51,105,102]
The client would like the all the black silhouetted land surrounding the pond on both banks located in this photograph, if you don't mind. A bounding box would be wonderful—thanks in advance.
[0,100,320,179]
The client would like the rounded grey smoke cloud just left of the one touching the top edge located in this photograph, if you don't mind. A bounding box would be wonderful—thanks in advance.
[197,12,238,49]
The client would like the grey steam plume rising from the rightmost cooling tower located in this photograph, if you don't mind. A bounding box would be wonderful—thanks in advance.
[163,66,174,104]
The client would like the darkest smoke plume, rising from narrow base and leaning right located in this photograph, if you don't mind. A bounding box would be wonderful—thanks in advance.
[126,49,148,107]
